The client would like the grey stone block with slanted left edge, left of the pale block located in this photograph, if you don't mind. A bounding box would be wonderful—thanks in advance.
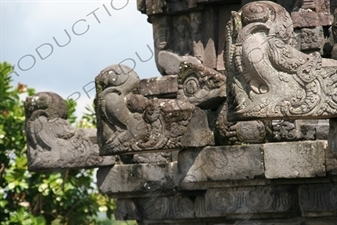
[178,145,264,187]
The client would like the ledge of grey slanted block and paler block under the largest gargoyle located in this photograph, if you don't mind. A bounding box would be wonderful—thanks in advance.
[178,141,330,190]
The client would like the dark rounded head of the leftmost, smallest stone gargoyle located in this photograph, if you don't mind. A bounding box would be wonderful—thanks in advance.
[24,92,68,119]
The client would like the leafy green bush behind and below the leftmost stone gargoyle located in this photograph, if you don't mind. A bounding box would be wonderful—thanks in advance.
[0,63,124,225]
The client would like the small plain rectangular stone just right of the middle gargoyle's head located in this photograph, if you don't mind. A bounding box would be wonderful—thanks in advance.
[139,75,178,98]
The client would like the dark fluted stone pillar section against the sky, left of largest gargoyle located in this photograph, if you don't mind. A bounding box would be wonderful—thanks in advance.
[144,0,241,75]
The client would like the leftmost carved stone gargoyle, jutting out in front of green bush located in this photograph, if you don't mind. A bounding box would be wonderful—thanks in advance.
[25,92,115,171]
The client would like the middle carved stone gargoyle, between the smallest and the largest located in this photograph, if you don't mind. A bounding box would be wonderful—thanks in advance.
[95,65,213,155]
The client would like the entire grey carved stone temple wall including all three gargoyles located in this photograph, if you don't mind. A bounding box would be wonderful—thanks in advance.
[25,0,337,225]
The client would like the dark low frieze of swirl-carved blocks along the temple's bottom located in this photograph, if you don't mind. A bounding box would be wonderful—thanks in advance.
[115,185,300,220]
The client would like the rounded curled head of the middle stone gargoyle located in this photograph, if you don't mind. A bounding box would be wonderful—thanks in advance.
[95,64,140,95]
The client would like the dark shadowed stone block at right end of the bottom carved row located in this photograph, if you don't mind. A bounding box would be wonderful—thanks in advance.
[298,184,337,217]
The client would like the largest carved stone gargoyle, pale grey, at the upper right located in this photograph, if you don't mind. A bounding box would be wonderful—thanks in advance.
[225,1,337,120]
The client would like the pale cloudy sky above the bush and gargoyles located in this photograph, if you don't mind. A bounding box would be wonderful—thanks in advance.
[0,0,159,115]
